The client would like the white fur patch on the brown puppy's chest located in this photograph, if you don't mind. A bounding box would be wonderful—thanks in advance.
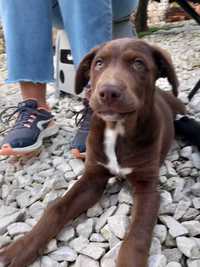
[104,122,133,176]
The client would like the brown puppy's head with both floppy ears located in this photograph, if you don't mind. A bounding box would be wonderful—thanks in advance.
[75,38,178,121]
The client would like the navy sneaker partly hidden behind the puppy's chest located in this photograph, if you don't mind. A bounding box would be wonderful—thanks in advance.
[71,99,92,159]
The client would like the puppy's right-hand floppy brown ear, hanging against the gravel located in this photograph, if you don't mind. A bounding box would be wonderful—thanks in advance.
[152,46,179,96]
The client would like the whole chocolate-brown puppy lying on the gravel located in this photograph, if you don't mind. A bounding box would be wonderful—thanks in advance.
[0,38,185,267]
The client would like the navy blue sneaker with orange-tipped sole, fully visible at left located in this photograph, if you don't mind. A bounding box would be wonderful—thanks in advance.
[0,99,58,156]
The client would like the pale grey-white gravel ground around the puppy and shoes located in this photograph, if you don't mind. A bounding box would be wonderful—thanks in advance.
[0,21,200,267]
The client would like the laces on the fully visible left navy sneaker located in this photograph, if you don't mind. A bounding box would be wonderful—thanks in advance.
[0,104,49,129]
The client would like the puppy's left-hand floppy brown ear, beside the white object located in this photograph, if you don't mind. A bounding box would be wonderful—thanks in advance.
[75,46,99,94]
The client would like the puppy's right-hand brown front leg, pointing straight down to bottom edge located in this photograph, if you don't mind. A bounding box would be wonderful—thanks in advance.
[117,180,160,267]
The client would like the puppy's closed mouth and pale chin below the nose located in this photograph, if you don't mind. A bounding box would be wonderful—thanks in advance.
[95,110,135,122]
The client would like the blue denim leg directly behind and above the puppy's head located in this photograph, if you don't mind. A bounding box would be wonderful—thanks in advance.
[58,0,112,65]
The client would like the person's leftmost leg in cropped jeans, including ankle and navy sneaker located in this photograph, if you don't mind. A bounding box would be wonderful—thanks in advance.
[0,0,57,155]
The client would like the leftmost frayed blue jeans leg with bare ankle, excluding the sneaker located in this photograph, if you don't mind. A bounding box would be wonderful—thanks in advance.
[0,0,53,105]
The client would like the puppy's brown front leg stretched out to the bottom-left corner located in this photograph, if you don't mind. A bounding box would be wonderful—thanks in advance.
[0,167,108,267]
